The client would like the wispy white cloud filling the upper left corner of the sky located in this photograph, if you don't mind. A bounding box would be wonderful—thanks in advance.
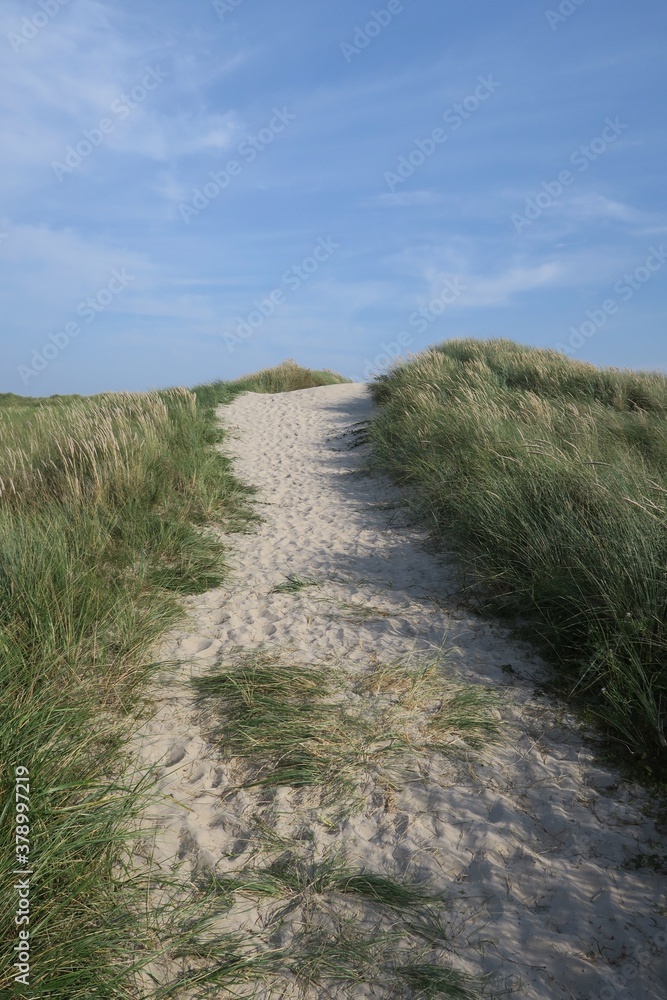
[0,0,241,197]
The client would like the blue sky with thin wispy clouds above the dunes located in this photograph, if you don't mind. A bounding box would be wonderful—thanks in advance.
[0,0,667,395]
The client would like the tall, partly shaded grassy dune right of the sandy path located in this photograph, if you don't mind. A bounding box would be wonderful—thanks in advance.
[370,340,667,781]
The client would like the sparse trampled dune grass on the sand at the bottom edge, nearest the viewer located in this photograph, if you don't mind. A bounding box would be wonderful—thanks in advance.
[190,792,490,1000]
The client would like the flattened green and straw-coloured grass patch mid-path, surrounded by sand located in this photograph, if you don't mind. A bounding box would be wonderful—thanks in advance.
[192,650,500,803]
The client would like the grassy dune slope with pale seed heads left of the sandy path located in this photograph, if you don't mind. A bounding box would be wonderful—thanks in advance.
[0,362,341,1000]
